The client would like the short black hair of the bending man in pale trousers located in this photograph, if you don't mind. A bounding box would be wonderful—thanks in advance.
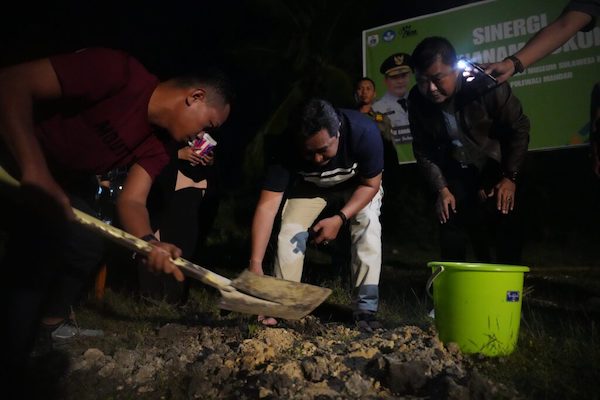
[299,98,340,139]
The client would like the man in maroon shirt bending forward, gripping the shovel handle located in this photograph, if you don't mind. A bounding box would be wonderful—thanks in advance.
[0,48,231,388]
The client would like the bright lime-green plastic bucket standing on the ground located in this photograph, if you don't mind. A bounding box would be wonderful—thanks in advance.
[427,261,529,356]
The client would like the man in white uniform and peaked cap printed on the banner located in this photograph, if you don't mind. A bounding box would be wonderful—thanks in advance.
[373,53,412,144]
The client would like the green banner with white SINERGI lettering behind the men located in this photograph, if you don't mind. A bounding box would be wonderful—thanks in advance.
[363,0,600,163]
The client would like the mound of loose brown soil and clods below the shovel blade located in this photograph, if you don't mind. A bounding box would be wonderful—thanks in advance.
[49,316,518,399]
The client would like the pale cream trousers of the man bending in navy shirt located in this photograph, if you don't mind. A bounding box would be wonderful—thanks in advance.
[274,188,383,312]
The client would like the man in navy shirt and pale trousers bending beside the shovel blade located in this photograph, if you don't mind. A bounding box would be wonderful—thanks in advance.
[249,99,383,330]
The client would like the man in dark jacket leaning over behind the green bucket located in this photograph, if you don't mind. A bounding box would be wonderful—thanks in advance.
[409,37,529,264]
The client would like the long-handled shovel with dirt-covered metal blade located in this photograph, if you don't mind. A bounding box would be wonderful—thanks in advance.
[0,166,331,319]
